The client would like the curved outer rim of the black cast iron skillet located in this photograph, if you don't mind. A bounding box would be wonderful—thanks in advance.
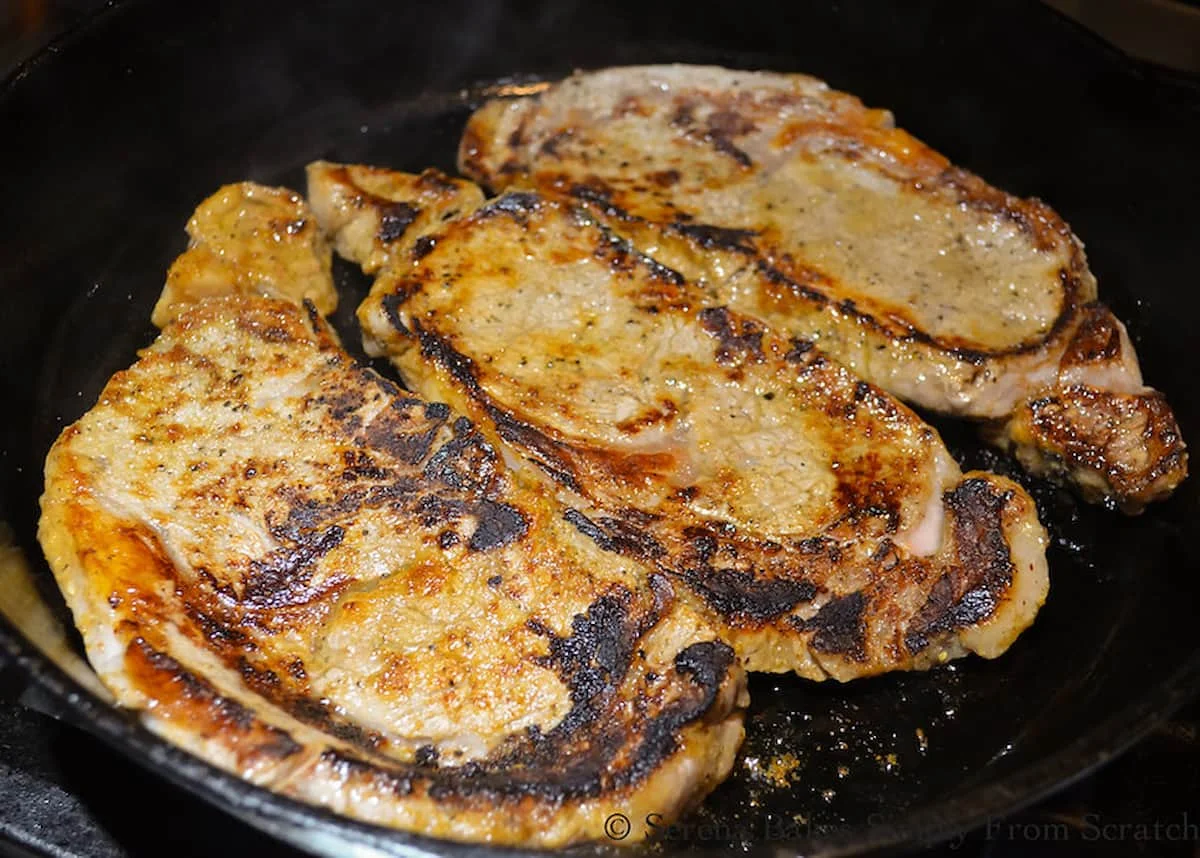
[0,0,1200,858]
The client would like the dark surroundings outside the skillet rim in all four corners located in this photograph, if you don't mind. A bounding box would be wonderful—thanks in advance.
[0,0,1200,858]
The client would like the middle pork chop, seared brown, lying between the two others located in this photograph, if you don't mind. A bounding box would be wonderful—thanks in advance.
[308,163,1048,679]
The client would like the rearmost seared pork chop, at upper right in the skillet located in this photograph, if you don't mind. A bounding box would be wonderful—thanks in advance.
[460,66,1187,511]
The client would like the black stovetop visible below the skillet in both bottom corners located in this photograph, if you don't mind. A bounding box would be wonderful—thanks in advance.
[0,652,1200,858]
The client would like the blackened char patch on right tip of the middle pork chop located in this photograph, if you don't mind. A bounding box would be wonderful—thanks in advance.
[905,478,1015,654]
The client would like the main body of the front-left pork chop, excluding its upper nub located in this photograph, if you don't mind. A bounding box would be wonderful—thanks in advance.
[40,297,744,846]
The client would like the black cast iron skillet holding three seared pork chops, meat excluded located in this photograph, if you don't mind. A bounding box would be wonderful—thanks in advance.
[0,0,1200,856]
